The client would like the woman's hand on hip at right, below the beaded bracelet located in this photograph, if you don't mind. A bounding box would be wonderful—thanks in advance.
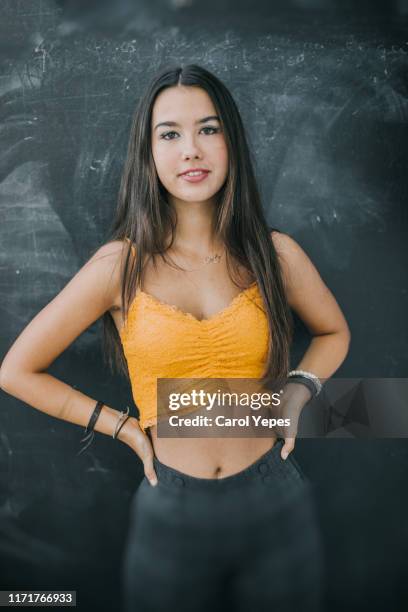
[275,382,312,459]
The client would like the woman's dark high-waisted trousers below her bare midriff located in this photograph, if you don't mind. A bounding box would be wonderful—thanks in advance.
[122,439,324,612]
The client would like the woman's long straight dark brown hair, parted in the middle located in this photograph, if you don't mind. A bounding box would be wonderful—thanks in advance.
[103,64,293,382]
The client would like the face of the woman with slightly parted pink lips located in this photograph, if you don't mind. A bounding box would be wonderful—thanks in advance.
[151,86,228,203]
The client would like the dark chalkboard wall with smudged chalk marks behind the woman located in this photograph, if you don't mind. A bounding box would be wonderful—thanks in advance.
[0,0,408,612]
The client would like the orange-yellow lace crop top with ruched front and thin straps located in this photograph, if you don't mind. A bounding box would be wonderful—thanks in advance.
[120,237,269,431]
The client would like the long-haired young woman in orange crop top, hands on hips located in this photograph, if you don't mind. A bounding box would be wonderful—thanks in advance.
[0,64,350,612]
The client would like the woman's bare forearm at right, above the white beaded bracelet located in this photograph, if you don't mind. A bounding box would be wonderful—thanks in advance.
[295,331,350,380]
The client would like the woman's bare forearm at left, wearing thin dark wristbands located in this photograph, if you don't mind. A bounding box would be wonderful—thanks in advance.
[2,372,138,444]
